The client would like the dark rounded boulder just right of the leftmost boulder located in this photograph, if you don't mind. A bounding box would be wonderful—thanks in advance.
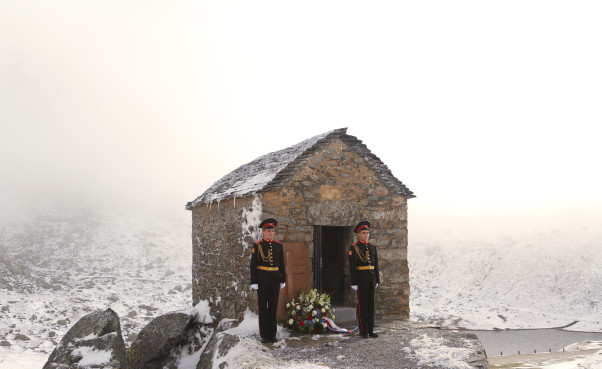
[127,313,194,369]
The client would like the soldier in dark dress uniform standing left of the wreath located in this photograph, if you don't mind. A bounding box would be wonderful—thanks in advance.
[251,218,286,343]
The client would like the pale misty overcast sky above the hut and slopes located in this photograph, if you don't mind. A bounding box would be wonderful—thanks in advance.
[0,0,602,239]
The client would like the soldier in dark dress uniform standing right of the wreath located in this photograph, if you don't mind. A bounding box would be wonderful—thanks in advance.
[349,221,380,338]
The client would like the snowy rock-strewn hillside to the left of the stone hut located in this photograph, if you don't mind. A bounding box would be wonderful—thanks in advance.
[0,198,192,352]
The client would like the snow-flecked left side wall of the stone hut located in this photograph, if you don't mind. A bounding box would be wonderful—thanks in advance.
[192,196,261,319]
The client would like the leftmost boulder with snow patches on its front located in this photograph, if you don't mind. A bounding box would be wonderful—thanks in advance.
[43,309,127,369]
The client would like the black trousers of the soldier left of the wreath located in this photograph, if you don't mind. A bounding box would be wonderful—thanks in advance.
[257,270,280,340]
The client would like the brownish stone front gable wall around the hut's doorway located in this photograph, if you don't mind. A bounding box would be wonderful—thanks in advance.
[262,140,410,319]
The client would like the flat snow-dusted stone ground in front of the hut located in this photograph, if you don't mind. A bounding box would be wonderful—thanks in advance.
[268,320,489,369]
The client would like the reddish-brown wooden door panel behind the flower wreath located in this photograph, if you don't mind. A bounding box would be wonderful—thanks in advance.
[277,242,311,321]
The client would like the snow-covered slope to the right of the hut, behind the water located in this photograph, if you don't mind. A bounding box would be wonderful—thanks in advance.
[408,218,602,332]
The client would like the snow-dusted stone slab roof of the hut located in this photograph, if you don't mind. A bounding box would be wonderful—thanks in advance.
[186,128,415,210]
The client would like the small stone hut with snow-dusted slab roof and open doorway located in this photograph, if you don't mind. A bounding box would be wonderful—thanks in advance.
[186,128,415,319]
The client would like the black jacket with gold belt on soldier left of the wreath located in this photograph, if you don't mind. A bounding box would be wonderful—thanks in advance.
[251,239,286,284]
